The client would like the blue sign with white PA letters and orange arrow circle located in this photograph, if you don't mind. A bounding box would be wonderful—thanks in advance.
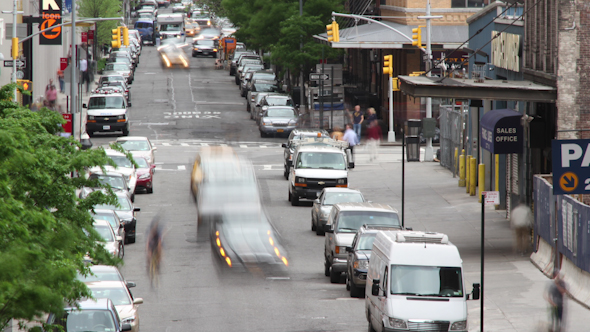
[551,139,590,195]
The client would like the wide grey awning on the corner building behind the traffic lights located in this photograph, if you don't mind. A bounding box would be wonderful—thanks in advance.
[313,21,469,49]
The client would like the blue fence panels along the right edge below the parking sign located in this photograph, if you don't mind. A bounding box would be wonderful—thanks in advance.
[533,175,590,272]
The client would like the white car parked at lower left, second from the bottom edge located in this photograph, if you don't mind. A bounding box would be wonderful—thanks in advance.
[85,281,143,332]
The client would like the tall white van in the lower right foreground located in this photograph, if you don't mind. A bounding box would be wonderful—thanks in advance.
[365,231,479,332]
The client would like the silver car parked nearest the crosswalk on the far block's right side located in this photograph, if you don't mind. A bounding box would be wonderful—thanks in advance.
[258,106,299,137]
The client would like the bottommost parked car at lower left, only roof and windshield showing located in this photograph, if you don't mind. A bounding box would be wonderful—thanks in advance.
[47,298,132,332]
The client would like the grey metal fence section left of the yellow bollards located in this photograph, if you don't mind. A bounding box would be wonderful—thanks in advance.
[439,105,463,172]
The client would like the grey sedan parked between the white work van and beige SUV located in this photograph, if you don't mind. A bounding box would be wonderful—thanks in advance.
[311,188,365,235]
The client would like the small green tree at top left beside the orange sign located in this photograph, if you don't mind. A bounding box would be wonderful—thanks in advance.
[78,0,122,47]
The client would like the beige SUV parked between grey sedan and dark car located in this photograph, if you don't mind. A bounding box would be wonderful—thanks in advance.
[324,202,402,283]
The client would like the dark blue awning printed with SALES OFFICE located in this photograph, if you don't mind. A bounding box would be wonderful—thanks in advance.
[480,109,523,154]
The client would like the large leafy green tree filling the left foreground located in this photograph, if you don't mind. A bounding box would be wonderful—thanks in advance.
[0,84,119,330]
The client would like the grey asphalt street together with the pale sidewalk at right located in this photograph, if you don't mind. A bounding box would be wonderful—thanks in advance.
[86,46,590,332]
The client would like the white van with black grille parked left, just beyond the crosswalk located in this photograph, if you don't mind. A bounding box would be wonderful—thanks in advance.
[82,89,129,136]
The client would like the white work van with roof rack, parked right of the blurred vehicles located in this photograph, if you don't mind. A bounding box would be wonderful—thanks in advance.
[289,138,351,206]
